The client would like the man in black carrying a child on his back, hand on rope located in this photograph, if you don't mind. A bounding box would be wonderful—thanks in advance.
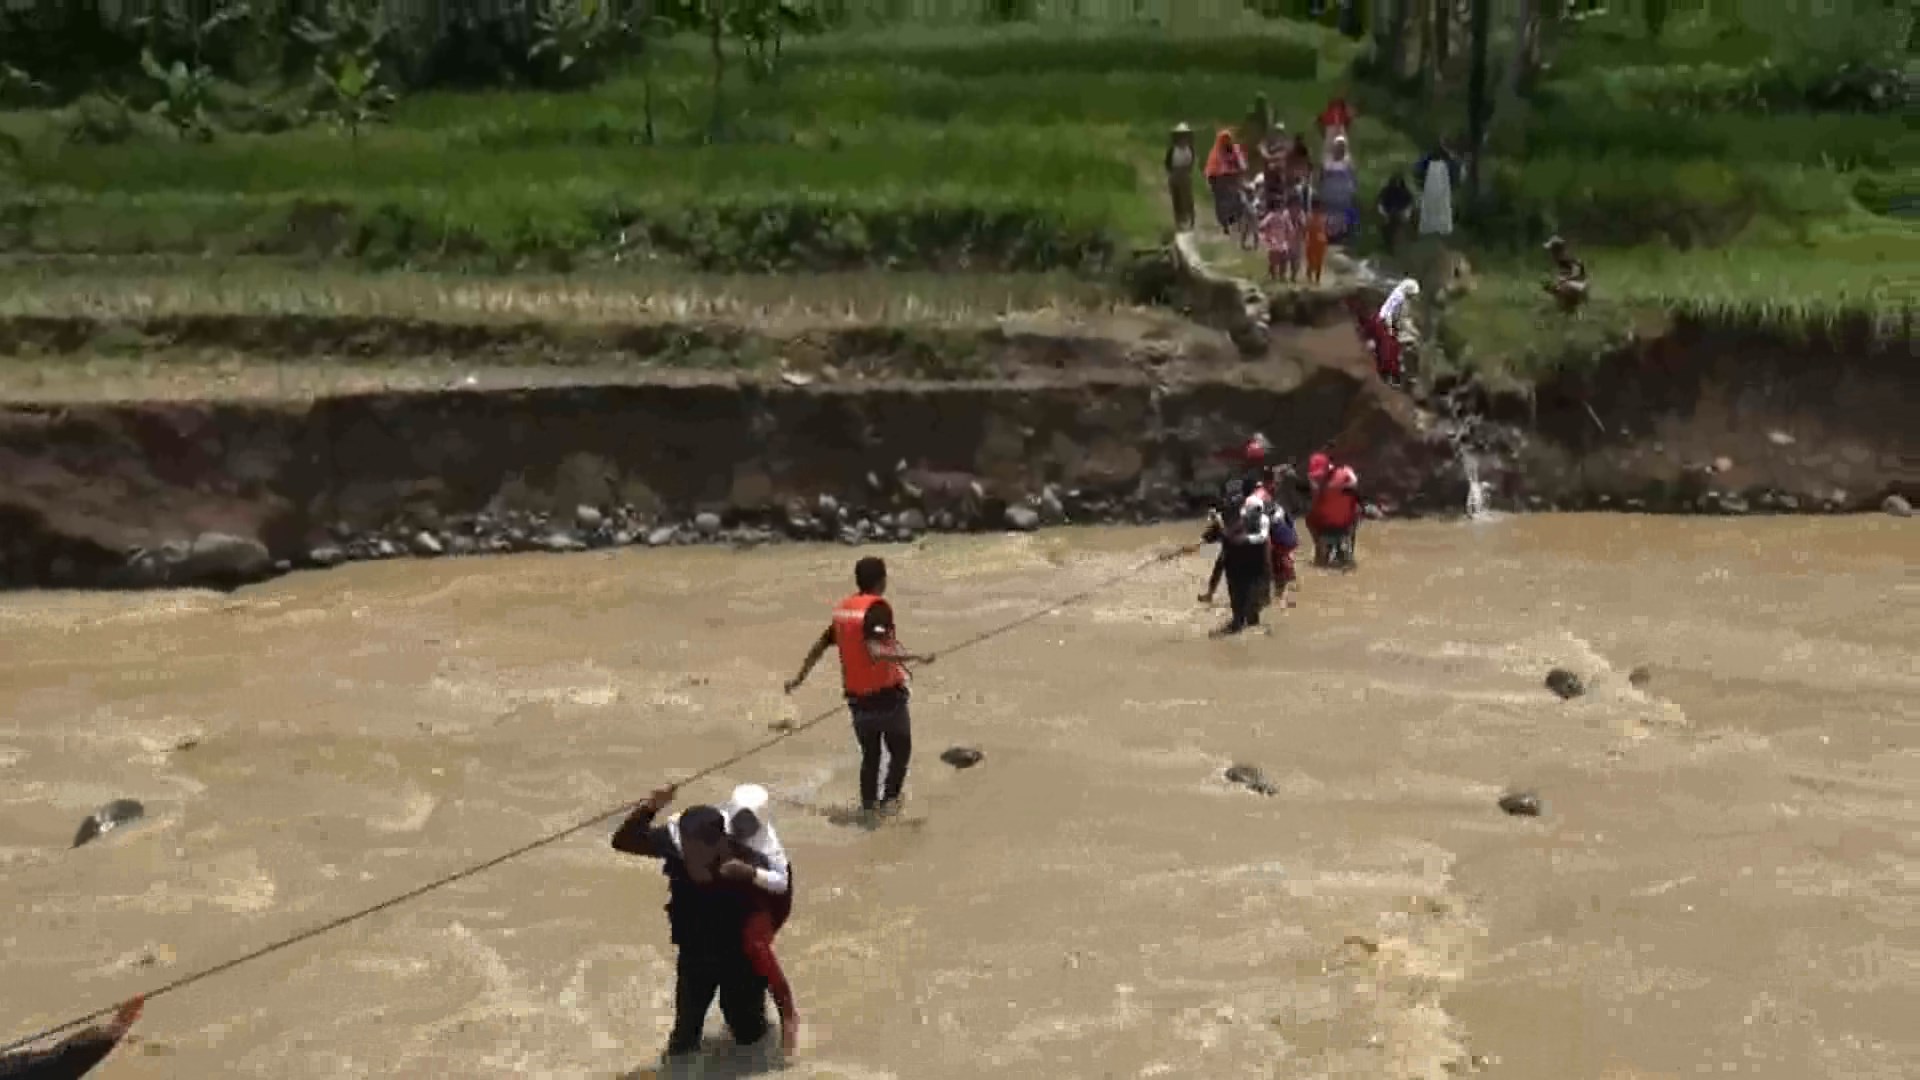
[612,786,799,1059]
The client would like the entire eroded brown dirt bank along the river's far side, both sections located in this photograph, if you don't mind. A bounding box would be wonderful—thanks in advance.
[0,313,1920,586]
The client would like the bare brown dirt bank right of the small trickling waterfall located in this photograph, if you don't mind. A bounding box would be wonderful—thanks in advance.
[1486,313,1920,513]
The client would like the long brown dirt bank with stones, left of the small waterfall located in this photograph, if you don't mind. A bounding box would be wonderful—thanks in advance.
[0,317,1457,586]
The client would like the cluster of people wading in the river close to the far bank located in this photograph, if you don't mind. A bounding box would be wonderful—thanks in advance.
[1200,434,1363,636]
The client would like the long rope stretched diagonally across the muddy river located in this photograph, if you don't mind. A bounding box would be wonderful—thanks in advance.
[0,544,1200,1055]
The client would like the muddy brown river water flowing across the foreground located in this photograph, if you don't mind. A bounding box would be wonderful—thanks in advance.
[0,517,1920,1080]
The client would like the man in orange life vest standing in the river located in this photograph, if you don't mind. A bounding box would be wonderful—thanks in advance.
[787,555,933,813]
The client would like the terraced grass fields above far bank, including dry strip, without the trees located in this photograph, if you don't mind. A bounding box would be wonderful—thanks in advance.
[0,4,1920,379]
